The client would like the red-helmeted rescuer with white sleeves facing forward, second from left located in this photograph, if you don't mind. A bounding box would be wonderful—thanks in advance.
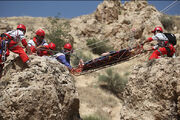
[28,29,50,56]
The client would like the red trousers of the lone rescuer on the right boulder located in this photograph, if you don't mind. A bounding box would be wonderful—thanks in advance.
[149,45,175,60]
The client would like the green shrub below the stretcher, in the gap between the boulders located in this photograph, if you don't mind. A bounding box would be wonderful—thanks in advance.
[98,69,128,93]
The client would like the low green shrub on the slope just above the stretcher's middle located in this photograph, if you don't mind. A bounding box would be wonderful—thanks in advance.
[86,38,112,55]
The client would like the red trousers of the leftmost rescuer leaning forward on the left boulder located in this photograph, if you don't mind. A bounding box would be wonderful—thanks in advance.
[11,45,29,63]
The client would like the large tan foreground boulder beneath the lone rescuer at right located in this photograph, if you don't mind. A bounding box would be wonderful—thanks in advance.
[120,57,180,120]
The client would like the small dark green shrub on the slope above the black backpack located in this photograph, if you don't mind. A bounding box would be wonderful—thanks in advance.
[160,15,174,30]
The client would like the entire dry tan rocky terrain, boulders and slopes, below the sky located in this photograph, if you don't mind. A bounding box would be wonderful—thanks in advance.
[0,0,180,120]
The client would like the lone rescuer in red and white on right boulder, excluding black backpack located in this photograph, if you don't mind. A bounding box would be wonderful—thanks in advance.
[145,27,175,60]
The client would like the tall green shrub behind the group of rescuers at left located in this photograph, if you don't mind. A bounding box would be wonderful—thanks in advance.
[46,17,73,51]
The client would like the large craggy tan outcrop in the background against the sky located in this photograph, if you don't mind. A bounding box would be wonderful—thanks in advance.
[70,0,165,50]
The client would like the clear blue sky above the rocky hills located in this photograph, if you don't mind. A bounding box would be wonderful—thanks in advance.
[0,0,180,18]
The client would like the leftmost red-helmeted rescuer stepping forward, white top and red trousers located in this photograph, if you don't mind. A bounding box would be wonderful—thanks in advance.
[4,24,30,63]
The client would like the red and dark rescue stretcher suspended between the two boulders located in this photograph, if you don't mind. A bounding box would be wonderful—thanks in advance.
[72,44,143,75]
